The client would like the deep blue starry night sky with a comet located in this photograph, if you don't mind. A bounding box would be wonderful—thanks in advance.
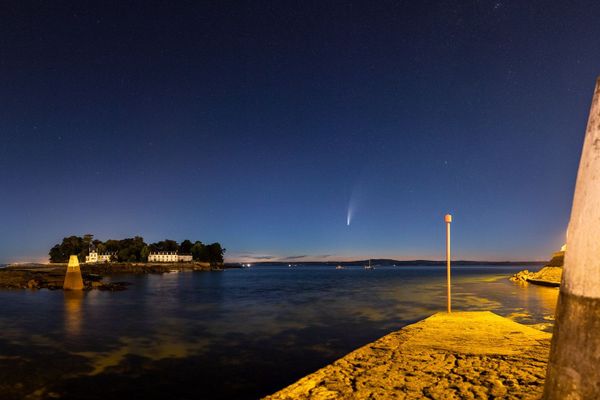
[0,0,600,262]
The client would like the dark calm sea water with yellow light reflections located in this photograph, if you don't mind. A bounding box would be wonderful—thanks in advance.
[0,266,558,399]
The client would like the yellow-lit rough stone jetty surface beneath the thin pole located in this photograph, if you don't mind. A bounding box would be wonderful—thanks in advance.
[266,311,552,400]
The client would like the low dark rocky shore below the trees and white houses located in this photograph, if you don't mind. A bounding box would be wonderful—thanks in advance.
[0,263,216,291]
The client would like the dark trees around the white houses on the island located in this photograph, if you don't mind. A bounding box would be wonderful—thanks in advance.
[49,235,225,265]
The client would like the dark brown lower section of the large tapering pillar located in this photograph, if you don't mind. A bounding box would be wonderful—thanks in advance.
[544,292,600,399]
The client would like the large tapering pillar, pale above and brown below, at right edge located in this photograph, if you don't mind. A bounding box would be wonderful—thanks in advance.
[543,78,600,399]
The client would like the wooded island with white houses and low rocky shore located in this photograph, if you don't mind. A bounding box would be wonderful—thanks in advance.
[0,234,226,290]
